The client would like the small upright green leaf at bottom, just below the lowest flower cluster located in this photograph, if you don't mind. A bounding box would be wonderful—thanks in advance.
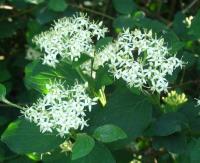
[72,134,95,160]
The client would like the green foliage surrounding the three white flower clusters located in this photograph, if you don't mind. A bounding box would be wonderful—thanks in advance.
[0,0,200,163]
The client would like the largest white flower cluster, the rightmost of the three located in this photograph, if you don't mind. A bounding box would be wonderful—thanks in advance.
[94,29,183,93]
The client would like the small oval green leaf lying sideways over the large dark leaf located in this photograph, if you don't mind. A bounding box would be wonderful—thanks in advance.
[93,124,127,143]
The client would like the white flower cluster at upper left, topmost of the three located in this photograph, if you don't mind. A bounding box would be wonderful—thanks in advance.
[33,13,107,67]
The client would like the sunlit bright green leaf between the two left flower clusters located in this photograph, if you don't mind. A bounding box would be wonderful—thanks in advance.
[25,61,81,93]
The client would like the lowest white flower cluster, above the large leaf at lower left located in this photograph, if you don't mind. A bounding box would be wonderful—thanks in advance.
[22,81,97,137]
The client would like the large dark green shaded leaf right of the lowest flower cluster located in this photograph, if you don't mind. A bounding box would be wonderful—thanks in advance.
[86,86,152,140]
